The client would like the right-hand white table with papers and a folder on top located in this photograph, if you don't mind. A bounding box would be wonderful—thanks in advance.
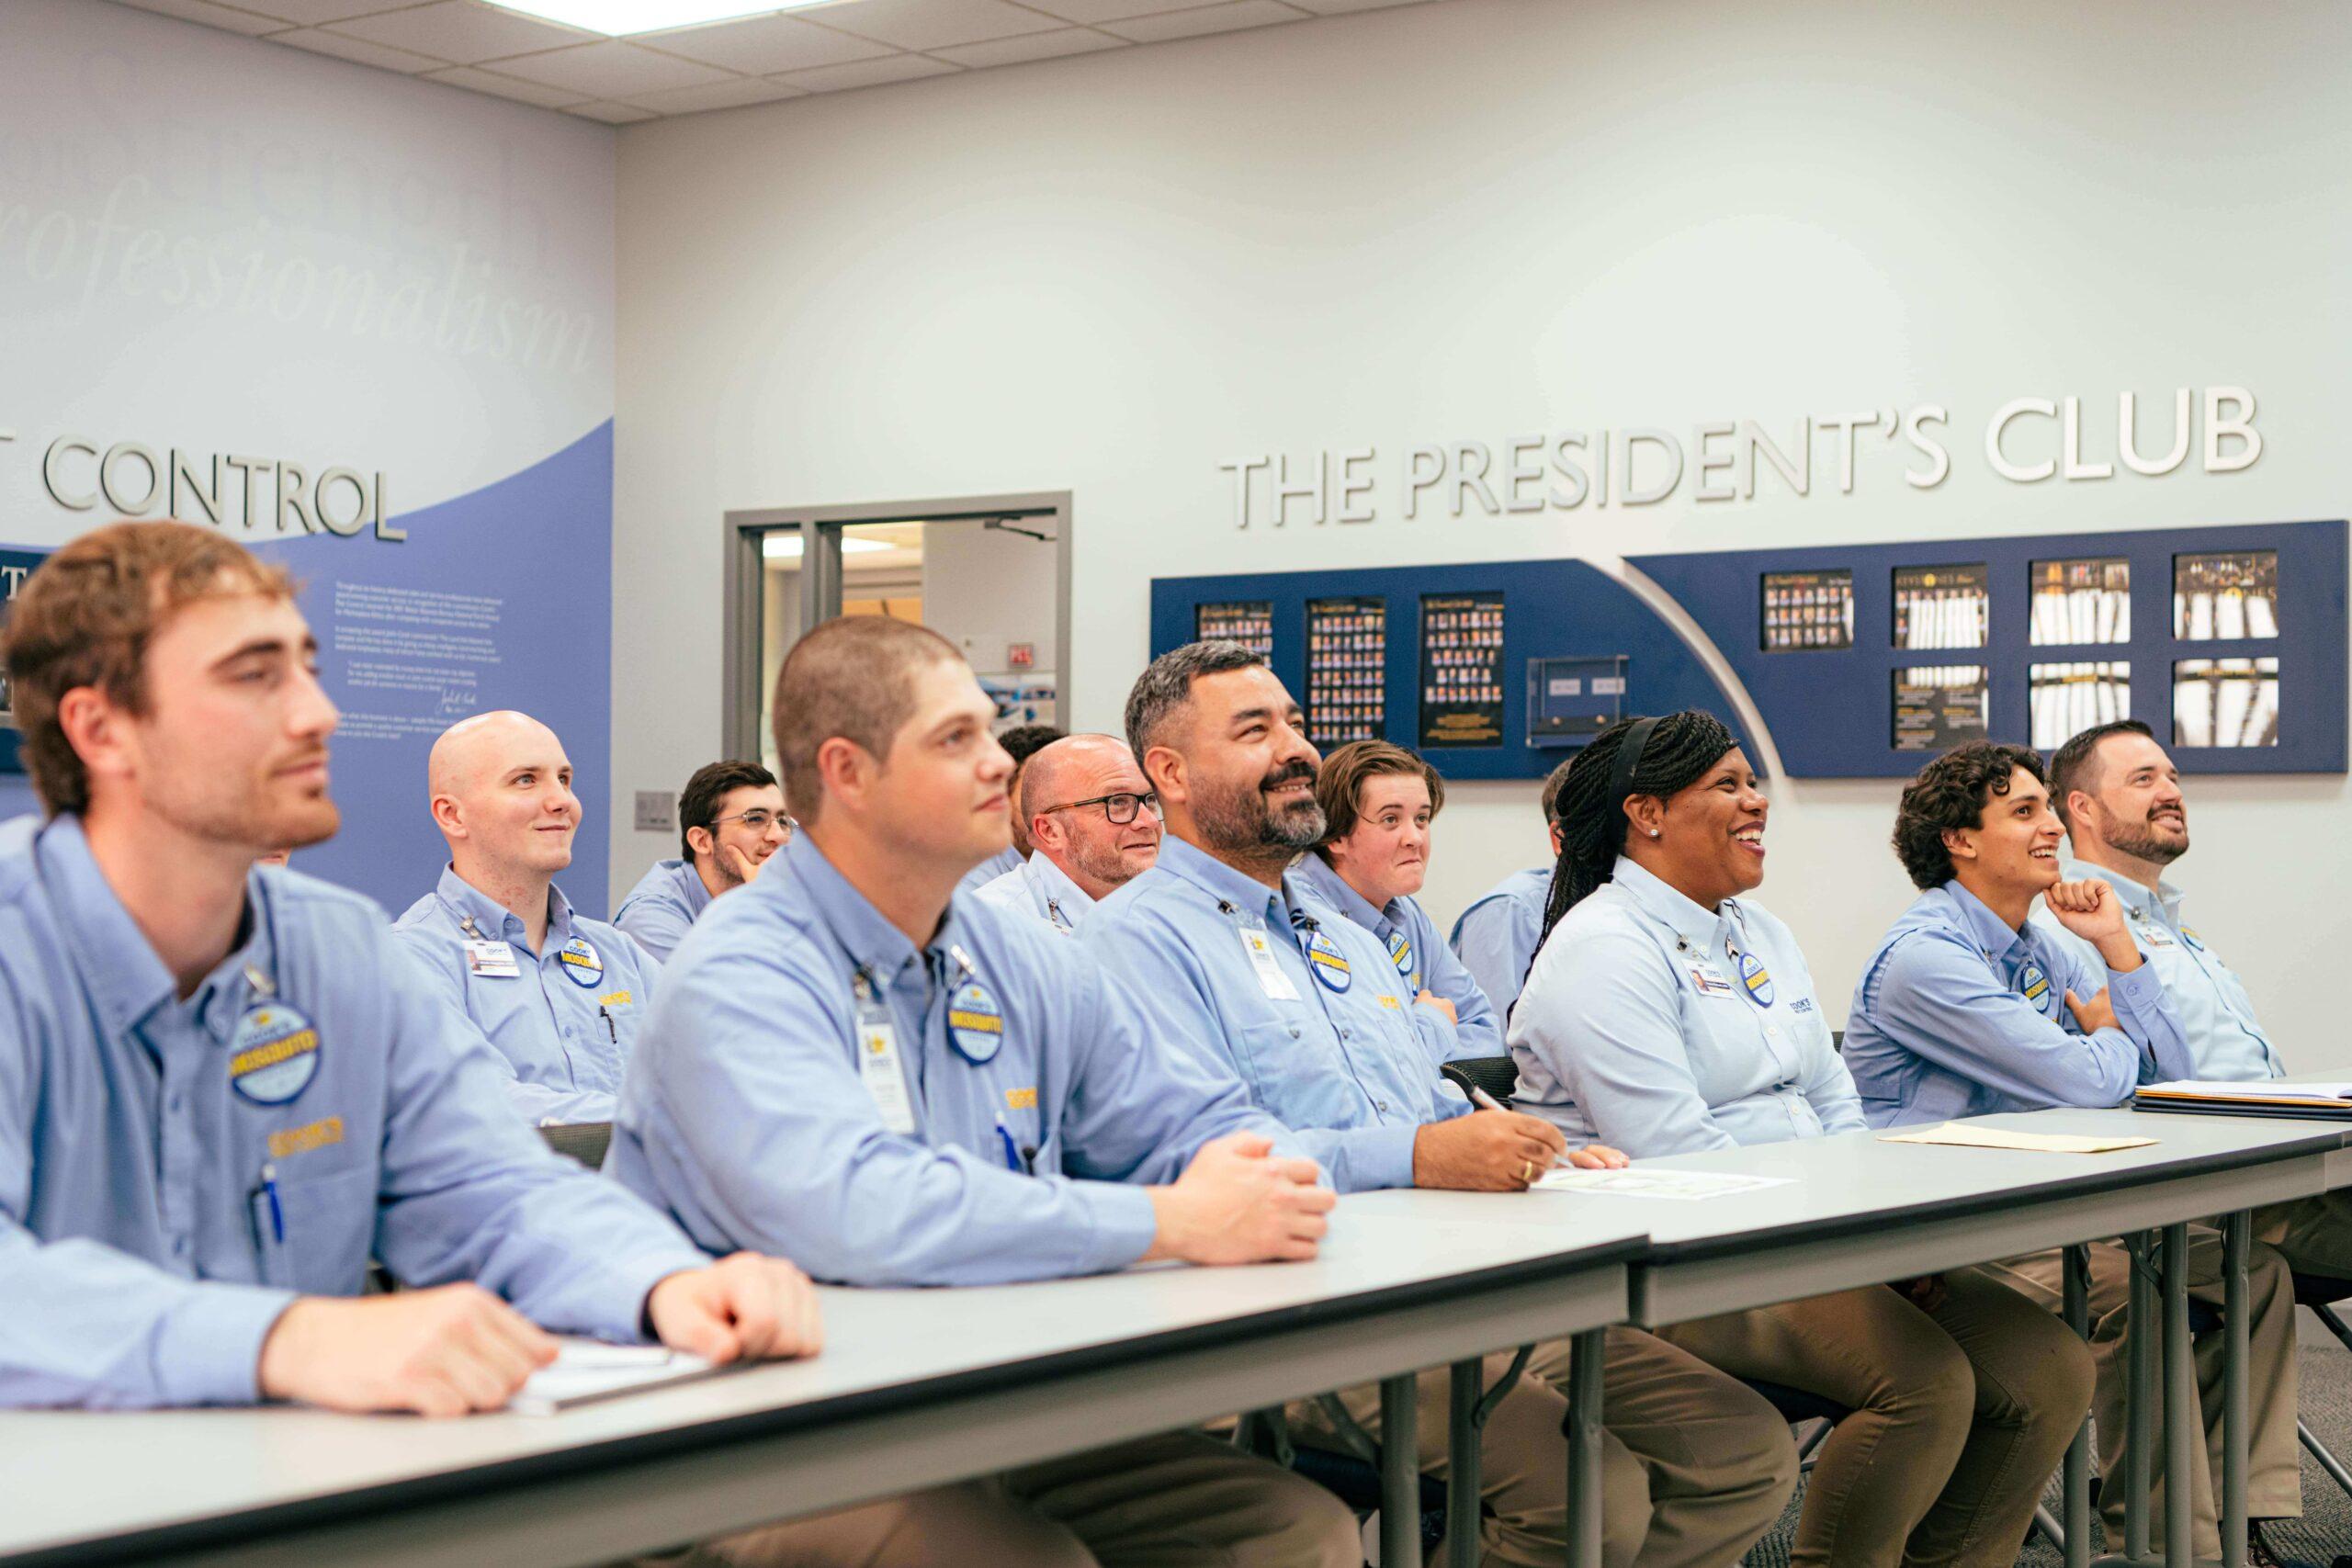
[1355,1110,2352,1568]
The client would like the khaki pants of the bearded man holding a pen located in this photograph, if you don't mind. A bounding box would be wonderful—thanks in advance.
[1289,1328,1797,1568]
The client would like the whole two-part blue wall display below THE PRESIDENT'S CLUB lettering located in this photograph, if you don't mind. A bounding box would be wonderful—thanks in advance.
[1152,520,2352,778]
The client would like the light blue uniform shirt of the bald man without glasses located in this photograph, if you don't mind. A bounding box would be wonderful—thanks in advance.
[393,867,661,1126]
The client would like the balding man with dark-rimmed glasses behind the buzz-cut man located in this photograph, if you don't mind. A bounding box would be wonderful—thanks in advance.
[976,736,1159,936]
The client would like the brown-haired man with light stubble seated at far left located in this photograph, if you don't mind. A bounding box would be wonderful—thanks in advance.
[0,522,992,1568]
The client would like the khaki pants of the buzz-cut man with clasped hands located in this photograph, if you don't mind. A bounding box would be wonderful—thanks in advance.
[639,1432,1364,1568]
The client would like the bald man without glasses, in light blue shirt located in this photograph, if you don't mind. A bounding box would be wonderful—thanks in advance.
[393,712,661,1126]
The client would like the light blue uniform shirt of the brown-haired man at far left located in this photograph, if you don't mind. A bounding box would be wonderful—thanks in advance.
[0,816,706,1405]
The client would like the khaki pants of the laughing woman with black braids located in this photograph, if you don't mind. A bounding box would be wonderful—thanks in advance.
[1663,1272,2093,1568]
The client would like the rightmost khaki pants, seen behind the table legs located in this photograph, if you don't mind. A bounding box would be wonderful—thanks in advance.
[1985,1222,2304,1559]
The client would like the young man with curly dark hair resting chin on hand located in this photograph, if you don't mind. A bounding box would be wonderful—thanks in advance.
[1844,740,2302,1556]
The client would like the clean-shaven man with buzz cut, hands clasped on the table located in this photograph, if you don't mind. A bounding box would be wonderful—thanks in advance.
[606,616,1362,1568]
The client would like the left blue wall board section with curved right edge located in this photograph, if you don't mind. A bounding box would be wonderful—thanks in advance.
[1152,562,1738,778]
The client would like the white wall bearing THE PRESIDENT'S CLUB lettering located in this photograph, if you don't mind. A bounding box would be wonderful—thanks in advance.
[614,0,2352,1067]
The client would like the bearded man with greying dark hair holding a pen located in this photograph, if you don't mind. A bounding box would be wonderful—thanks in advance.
[1080,642,1794,1568]
